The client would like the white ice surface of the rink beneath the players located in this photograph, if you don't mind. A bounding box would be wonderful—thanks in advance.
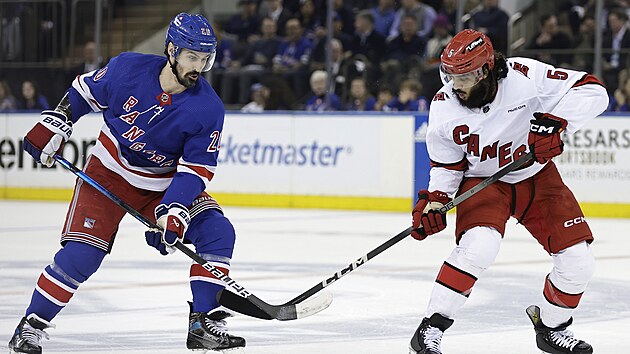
[0,201,630,354]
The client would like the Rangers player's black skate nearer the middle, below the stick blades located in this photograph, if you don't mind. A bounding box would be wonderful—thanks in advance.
[186,302,245,354]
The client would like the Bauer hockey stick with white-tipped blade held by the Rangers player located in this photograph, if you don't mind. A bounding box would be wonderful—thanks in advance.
[54,154,332,321]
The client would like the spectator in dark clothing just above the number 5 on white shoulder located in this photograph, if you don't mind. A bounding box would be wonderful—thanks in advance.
[527,15,573,67]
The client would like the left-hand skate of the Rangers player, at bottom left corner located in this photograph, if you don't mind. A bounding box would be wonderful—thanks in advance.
[9,313,55,354]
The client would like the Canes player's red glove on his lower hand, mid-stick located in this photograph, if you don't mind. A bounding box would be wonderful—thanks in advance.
[411,189,451,240]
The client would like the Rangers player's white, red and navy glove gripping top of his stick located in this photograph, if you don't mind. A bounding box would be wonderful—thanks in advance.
[24,110,72,167]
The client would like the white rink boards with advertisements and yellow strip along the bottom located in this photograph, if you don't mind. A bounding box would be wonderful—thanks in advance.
[0,112,630,217]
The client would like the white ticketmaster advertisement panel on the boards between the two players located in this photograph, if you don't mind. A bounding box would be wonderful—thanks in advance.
[212,114,414,198]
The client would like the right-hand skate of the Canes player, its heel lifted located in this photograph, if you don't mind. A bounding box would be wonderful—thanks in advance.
[526,305,593,354]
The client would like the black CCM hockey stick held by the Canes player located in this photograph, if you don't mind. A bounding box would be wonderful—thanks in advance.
[218,152,533,320]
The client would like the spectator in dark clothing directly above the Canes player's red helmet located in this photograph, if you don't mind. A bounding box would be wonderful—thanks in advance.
[472,0,510,53]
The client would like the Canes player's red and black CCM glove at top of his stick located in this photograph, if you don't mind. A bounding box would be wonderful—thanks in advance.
[527,112,567,163]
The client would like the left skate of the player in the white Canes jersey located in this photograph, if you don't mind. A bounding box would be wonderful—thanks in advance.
[409,313,453,354]
